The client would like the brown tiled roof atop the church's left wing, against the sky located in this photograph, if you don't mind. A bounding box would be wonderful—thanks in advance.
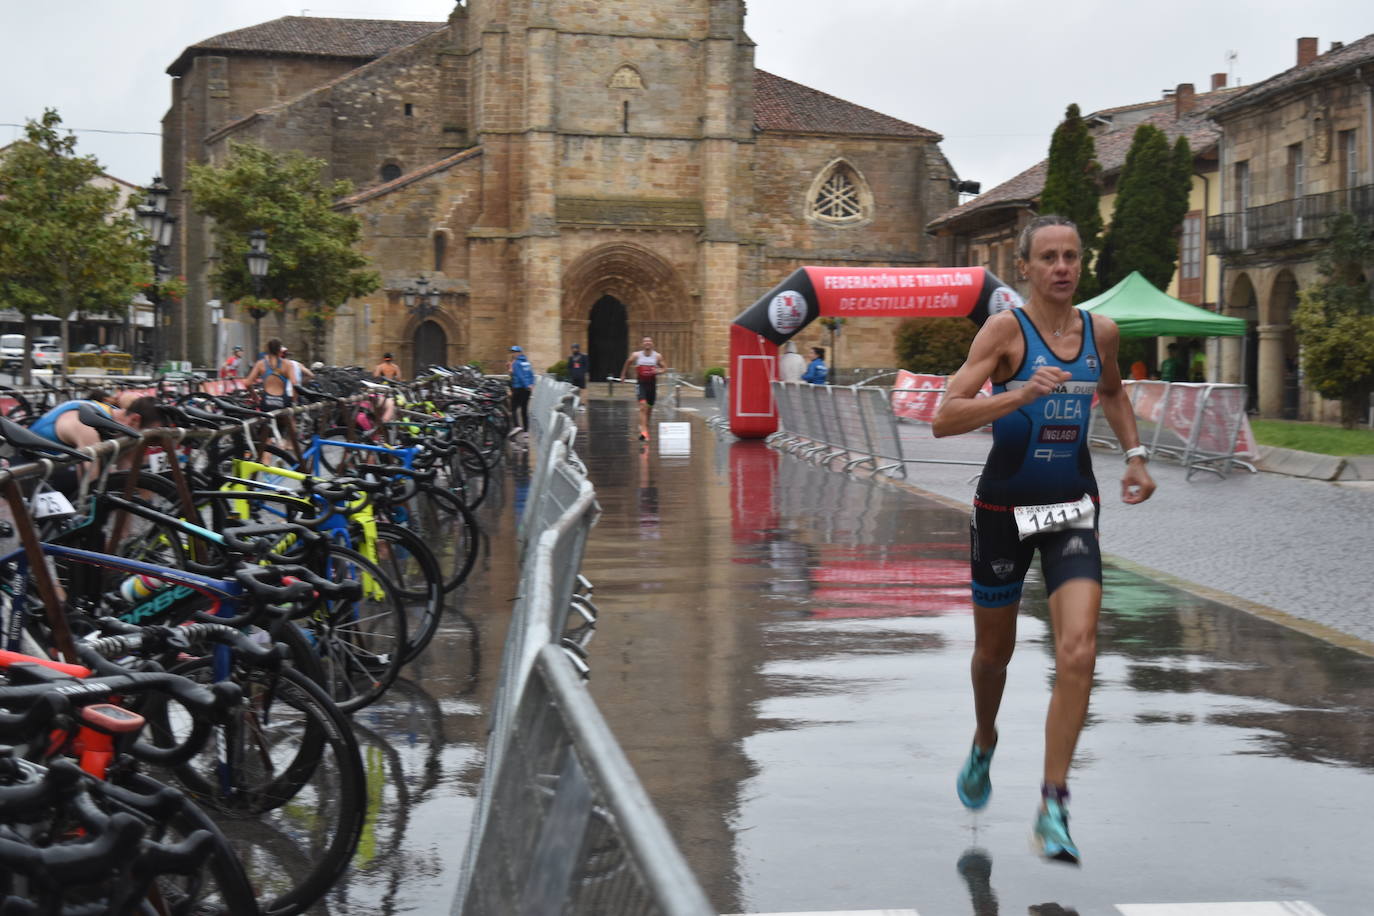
[168,16,445,76]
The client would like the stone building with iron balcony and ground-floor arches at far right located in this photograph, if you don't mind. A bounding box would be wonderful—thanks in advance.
[1206,34,1374,420]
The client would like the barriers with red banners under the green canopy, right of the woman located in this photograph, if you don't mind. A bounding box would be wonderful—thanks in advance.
[1088,380,1257,479]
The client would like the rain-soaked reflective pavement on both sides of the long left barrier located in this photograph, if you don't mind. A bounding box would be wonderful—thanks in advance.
[317,398,1374,916]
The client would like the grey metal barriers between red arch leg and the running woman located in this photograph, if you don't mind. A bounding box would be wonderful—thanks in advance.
[768,382,982,478]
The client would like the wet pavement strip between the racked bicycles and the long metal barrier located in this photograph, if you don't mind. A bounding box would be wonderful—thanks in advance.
[311,467,528,916]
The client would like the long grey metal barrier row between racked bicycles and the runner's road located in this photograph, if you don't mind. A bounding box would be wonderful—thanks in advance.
[451,383,713,916]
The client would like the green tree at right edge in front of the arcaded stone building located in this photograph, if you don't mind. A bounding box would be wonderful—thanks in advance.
[1293,213,1374,427]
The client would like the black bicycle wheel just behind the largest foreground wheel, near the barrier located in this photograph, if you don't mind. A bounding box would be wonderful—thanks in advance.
[300,544,405,713]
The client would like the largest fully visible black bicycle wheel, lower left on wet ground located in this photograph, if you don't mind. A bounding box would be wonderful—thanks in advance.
[150,658,367,916]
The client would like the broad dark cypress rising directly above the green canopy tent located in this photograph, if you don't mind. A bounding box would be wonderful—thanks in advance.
[1098,124,1193,290]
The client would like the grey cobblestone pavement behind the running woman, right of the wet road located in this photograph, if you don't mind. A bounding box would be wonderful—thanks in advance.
[701,401,1374,655]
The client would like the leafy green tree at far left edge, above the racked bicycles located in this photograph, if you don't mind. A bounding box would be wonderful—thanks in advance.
[0,108,153,383]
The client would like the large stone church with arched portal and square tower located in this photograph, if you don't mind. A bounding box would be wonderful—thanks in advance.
[164,0,955,378]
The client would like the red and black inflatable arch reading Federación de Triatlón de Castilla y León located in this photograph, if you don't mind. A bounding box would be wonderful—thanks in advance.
[730,268,1021,439]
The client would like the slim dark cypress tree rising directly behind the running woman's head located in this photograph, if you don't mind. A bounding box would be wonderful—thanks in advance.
[1040,104,1102,302]
